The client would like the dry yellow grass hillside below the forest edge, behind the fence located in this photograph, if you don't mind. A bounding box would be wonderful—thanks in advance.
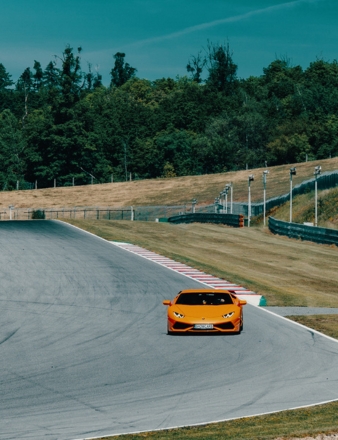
[0,158,338,209]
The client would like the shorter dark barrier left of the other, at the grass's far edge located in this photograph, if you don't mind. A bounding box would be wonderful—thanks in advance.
[168,212,244,228]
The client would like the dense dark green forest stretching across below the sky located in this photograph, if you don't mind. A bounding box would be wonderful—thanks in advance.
[0,42,338,190]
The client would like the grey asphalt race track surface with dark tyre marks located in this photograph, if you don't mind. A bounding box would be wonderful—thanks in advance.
[0,221,338,440]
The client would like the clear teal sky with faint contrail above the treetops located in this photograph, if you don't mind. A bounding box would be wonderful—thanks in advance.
[0,0,338,84]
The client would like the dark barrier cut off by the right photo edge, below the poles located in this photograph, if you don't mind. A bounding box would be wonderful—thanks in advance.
[269,217,338,246]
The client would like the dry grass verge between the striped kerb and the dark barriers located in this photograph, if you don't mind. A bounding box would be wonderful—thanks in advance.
[62,220,338,307]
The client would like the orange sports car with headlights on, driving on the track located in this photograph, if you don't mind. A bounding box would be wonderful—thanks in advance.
[163,289,246,335]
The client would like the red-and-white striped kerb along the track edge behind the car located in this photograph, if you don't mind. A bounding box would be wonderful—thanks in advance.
[111,241,267,306]
